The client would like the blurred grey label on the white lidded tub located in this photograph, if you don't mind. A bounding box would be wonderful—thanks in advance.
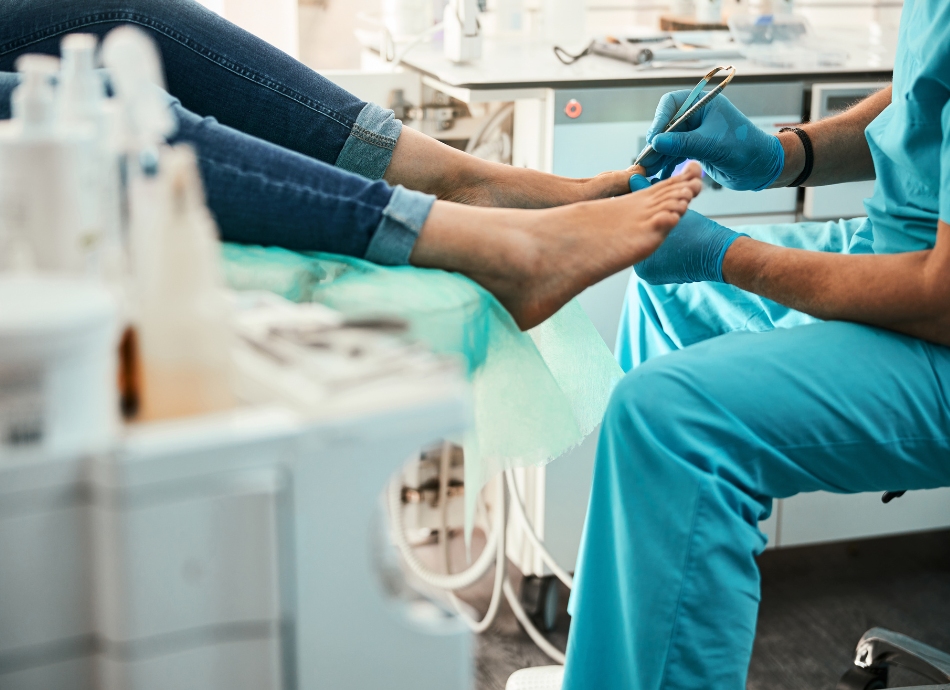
[0,366,46,450]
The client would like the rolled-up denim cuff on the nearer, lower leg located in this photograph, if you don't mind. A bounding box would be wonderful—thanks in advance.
[365,185,435,266]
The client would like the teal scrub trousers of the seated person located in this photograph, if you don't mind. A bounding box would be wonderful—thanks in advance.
[563,220,950,690]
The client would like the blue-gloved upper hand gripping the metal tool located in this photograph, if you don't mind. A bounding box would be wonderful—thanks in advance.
[643,90,785,191]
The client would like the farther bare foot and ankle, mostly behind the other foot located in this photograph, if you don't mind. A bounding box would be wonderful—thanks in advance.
[384,127,632,208]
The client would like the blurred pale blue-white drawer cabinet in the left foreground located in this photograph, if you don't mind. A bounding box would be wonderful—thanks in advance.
[0,396,474,690]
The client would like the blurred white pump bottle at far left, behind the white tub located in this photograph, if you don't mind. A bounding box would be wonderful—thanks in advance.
[0,55,83,273]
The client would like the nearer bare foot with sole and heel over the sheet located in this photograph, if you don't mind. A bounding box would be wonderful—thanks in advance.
[410,164,702,330]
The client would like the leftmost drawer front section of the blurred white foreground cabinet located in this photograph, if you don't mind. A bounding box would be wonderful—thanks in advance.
[0,459,95,690]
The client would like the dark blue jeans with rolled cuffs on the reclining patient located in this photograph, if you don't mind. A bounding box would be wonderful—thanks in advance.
[0,0,435,264]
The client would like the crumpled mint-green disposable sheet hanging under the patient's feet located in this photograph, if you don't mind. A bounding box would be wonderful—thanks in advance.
[223,244,623,533]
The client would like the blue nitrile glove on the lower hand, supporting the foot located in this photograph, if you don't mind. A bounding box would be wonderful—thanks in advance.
[630,175,748,285]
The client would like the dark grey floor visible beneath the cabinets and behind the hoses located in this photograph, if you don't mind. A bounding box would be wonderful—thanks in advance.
[470,531,950,690]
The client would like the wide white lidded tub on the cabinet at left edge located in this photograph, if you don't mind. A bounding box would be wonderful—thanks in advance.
[0,274,118,458]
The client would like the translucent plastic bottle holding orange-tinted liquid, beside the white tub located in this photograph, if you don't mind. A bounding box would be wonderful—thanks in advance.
[132,145,235,420]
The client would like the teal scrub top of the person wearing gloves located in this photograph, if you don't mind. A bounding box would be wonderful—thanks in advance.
[854,0,950,254]
